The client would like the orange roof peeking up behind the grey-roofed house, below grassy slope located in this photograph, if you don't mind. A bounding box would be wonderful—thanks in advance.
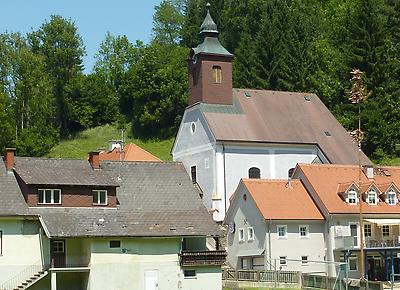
[99,143,161,162]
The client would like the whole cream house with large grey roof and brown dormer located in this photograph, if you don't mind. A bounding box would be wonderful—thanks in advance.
[0,150,226,290]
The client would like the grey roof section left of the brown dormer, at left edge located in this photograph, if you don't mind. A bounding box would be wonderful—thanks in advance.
[0,159,28,216]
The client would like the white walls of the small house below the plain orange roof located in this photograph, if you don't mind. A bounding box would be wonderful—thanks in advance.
[226,187,327,273]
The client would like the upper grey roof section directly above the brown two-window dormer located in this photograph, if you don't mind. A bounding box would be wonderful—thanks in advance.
[14,157,117,186]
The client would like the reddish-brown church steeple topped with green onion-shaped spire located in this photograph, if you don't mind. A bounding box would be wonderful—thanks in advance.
[189,3,233,105]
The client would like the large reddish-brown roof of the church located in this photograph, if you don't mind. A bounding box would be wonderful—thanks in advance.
[202,89,371,164]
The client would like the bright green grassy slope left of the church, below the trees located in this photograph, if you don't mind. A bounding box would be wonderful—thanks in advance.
[47,125,174,161]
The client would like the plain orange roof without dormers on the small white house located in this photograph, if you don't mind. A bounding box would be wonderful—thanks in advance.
[242,179,324,220]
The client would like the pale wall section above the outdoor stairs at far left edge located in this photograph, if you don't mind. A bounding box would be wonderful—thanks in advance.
[0,219,42,285]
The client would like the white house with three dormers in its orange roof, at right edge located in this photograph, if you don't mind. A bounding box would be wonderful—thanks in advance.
[293,164,400,280]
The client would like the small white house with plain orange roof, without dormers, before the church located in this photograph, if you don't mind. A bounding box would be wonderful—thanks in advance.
[224,179,327,273]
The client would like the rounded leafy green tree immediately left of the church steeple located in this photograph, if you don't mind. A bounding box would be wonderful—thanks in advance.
[123,43,188,138]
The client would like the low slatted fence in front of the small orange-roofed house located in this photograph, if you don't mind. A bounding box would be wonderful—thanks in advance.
[222,269,301,284]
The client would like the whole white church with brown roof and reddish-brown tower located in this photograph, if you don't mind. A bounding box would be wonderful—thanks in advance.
[172,4,371,222]
